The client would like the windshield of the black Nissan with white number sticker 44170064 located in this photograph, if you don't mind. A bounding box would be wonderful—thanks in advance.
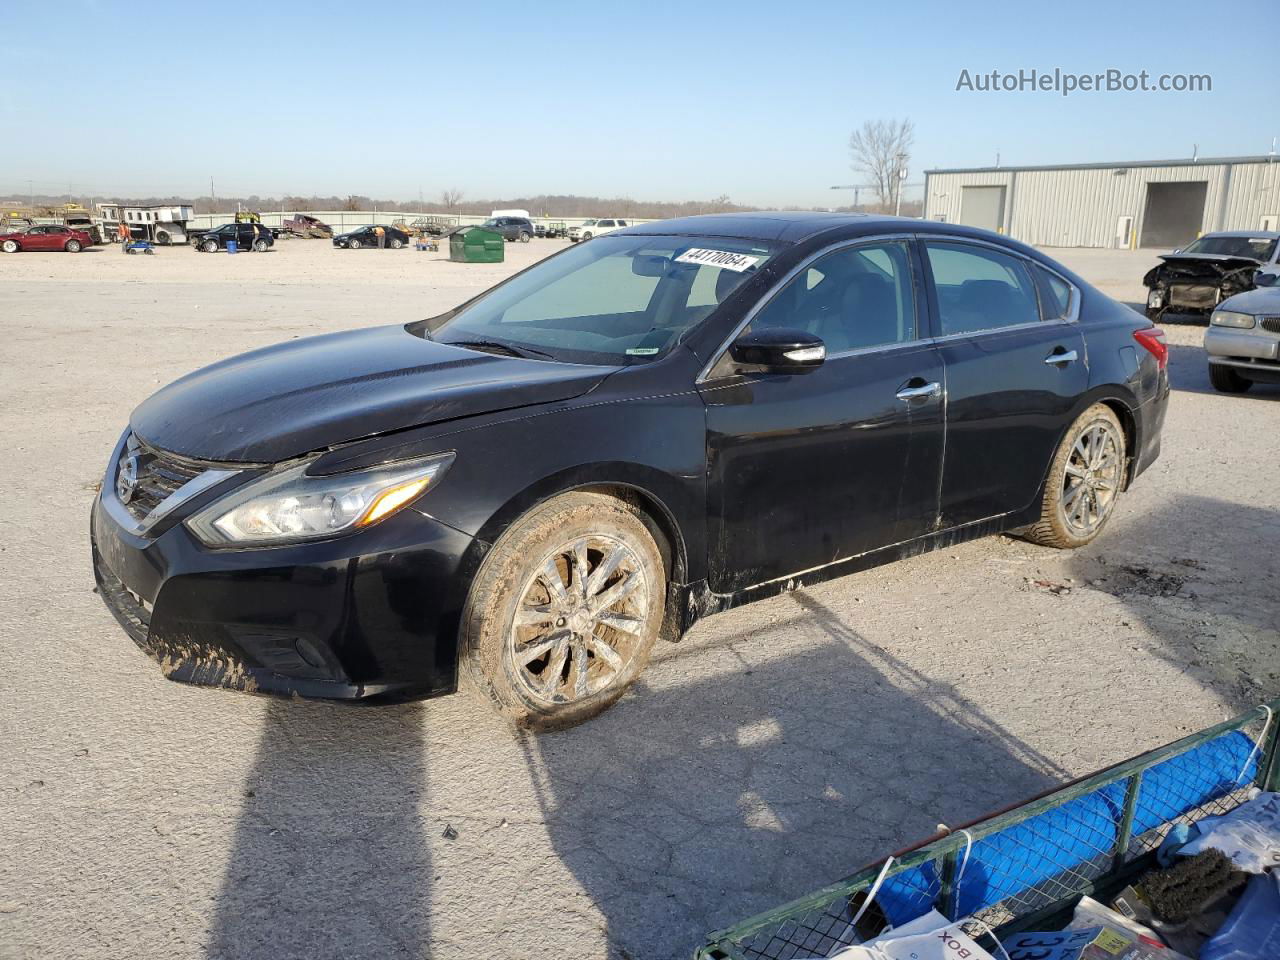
[431,234,778,364]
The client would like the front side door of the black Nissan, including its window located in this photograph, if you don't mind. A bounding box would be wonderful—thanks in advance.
[700,239,943,593]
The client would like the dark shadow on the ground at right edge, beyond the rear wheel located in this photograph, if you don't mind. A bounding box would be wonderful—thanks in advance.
[1069,495,1280,712]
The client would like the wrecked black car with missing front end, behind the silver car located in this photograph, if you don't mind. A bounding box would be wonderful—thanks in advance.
[1142,230,1280,323]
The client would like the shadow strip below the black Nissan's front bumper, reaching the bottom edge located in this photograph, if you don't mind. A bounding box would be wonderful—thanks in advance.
[206,699,433,960]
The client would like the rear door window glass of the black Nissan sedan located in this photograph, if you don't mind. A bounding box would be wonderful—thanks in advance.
[925,243,1041,337]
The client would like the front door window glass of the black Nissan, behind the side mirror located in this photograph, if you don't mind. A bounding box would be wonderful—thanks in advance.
[751,241,915,356]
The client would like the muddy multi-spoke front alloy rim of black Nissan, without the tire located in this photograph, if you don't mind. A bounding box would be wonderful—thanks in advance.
[507,536,649,705]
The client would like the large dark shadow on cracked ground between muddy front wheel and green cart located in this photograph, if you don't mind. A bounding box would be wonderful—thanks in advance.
[524,593,1068,960]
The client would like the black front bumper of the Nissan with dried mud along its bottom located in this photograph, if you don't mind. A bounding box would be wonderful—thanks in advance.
[90,490,477,699]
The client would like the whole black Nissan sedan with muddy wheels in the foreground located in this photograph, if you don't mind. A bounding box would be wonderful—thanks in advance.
[92,214,1169,728]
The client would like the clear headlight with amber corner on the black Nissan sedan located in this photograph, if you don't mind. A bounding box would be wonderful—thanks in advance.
[187,453,453,547]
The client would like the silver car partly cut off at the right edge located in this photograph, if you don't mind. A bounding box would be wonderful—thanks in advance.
[1204,278,1280,393]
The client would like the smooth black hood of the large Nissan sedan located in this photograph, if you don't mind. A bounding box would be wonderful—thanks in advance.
[129,325,614,463]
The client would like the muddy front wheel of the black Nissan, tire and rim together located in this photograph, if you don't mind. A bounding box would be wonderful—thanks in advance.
[461,493,667,731]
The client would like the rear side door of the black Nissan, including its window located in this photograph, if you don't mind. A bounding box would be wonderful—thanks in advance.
[923,239,1088,527]
